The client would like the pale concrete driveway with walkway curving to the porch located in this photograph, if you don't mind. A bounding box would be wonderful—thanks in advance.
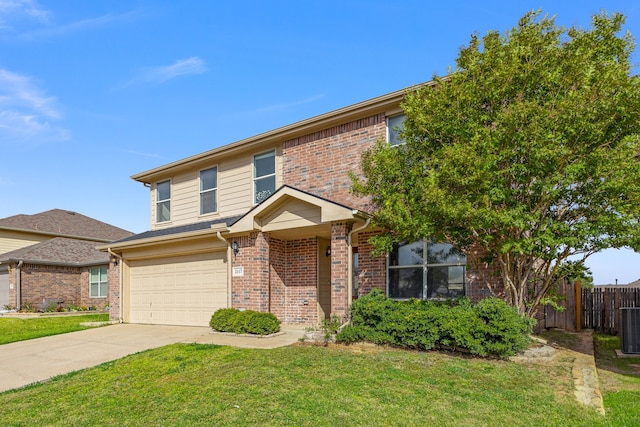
[0,324,304,392]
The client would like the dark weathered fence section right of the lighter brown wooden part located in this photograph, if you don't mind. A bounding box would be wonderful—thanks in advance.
[582,286,640,335]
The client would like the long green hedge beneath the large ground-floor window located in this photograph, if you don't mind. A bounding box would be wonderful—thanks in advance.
[336,289,533,356]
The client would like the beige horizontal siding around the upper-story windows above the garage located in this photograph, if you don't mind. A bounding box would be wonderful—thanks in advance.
[150,148,283,229]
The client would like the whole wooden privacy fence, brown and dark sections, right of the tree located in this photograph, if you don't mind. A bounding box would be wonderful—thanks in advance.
[544,283,640,335]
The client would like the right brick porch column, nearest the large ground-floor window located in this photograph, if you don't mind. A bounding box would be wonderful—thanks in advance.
[331,221,353,318]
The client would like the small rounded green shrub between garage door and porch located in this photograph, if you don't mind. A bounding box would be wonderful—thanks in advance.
[209,308,280,335]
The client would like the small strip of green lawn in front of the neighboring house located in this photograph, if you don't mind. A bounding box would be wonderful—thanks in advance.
[0,313,109,344]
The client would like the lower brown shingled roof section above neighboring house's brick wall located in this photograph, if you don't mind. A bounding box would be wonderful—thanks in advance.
[0,237,109,267]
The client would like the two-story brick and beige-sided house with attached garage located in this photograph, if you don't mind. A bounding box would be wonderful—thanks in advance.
[101,84,500,326]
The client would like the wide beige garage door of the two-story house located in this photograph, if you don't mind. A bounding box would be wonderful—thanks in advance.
[129,252,227,326]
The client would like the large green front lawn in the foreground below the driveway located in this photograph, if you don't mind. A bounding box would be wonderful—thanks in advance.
[0,344,615,426]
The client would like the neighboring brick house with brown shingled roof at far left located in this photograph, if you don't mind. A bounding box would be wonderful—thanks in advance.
[0,209,133,309]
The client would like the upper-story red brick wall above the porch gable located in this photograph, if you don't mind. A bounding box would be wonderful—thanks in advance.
[282,114,386,210]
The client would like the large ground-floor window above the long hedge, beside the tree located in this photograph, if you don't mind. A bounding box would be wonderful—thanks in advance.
[387,240,467,299]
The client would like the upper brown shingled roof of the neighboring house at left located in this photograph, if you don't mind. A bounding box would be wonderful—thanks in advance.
[0,209,133,242]
